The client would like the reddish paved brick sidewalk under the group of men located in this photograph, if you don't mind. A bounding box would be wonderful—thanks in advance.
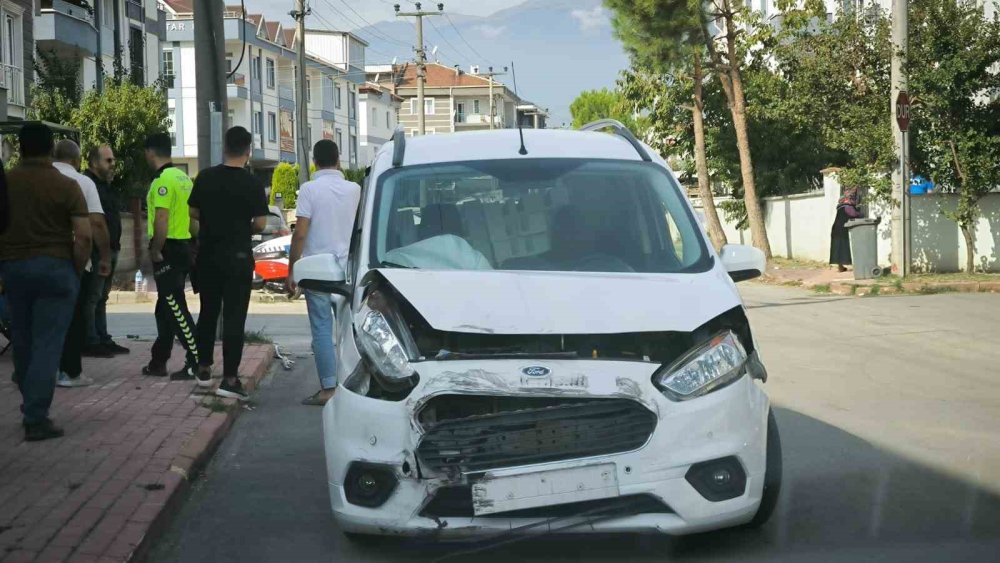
[0,342,273,563]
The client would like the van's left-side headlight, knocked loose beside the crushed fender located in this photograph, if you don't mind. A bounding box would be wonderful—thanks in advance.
[356,292,416,391]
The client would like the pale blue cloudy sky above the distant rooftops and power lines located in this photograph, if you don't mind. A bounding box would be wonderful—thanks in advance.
[252,0,628,127]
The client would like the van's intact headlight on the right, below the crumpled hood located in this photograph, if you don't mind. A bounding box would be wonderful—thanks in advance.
[653,330,747,401]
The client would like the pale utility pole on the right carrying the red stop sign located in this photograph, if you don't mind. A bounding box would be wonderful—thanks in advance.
[887,0,910,276]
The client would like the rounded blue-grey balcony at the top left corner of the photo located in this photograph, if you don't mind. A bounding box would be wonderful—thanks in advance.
[35,0,98,56]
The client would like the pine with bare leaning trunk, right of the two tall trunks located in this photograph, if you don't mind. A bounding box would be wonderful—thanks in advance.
[605,0,796,258]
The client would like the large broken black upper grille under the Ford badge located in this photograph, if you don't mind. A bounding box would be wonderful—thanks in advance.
[417,395,656,473]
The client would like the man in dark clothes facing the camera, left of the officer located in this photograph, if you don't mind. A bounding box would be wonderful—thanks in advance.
[80,145,129,357]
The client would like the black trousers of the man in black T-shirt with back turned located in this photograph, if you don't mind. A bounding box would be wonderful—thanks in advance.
[198,249,253,377]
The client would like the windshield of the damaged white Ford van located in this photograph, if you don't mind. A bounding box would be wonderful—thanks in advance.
[372,159,711,273]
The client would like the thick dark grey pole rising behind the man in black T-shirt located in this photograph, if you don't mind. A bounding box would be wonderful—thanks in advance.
[194,0,227,169]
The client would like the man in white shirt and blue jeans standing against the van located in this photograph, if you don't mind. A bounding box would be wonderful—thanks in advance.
[288,139,361,406]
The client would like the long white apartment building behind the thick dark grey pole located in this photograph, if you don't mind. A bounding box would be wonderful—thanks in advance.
[161,0,358,177]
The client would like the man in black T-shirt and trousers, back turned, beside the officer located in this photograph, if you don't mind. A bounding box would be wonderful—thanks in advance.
[188,127,267,400]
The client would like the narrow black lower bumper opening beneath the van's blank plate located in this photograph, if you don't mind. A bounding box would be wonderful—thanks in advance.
[420,485,673,518]
